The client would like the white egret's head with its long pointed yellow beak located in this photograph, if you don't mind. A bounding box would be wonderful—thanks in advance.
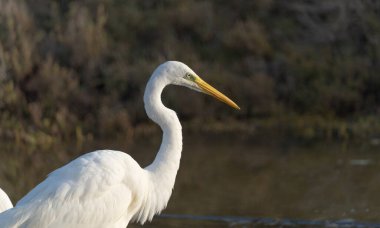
[159,61,240,110]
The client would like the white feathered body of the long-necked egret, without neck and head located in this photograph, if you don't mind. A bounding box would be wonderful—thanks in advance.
[0,150,163,228]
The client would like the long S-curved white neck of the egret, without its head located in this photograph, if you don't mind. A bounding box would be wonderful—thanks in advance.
[144,74,182,219]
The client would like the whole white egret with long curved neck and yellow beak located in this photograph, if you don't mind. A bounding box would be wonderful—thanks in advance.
[0,61,240,228]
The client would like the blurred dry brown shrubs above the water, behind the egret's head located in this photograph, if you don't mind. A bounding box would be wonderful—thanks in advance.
[0,0,380,145]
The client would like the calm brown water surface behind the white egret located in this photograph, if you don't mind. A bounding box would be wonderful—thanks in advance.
[0,134,380,227]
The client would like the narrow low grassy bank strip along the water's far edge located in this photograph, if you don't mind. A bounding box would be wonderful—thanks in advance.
[0,115,380,148]
